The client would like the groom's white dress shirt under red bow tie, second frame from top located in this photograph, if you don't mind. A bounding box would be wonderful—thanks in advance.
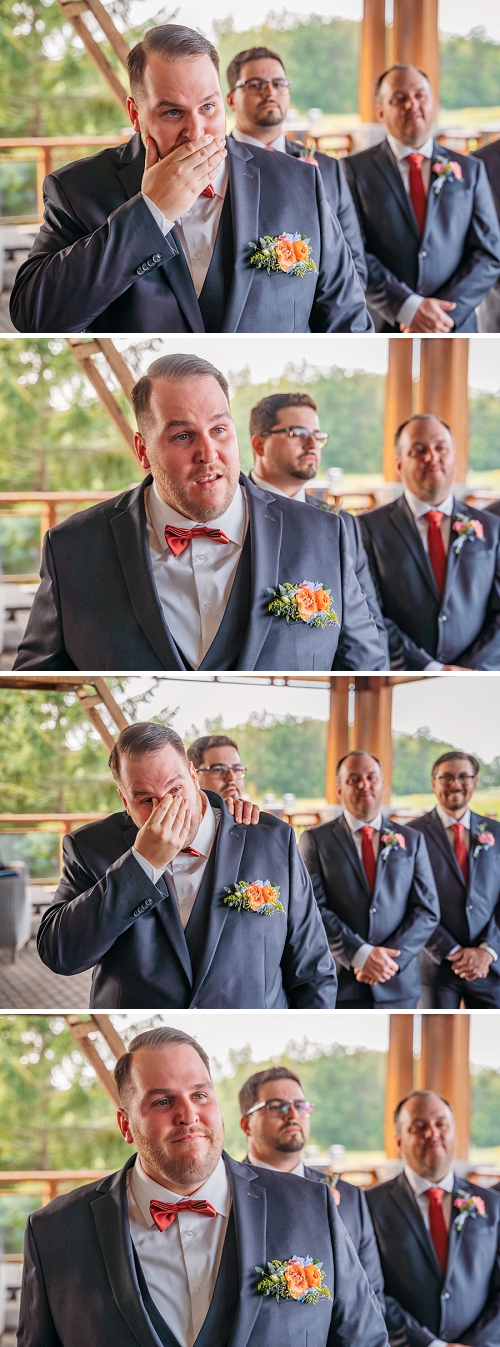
[144,482,248,669]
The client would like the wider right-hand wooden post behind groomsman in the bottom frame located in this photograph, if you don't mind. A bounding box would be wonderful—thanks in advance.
[419,1010,470,1160]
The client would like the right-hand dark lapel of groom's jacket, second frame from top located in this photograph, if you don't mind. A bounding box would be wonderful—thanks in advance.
[239,477,284,669]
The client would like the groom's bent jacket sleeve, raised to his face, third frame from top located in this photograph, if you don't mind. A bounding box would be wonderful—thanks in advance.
[36,836,163,975]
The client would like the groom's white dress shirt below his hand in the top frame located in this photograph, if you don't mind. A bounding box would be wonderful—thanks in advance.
[142,160,228,298]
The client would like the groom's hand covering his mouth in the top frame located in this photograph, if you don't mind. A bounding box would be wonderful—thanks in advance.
[142,136,228,220]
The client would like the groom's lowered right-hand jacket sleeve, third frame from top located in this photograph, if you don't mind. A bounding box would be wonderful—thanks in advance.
[282,830,337,1010]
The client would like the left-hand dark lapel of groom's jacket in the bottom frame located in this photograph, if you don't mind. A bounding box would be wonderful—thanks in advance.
[92,1156,162,1347]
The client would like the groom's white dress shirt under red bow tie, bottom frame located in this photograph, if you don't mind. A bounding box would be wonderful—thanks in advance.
[127,1156,230,1347]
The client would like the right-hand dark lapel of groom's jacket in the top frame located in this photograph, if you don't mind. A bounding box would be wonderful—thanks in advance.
[222,136,260,333]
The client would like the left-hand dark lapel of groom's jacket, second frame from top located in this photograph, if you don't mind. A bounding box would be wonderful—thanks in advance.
[111,477,185,669]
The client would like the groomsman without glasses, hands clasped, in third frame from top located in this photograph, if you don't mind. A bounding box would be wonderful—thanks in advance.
[299,749,439,1010]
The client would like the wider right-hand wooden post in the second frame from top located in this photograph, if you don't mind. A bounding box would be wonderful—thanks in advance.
[415,337,469,482]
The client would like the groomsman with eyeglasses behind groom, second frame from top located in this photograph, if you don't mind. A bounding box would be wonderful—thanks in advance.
[249,393,388,667]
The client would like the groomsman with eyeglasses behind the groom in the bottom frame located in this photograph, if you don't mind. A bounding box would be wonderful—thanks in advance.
[239,1067,384,1312]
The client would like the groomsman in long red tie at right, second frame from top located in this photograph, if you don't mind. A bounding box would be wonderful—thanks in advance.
[360,412,500,669]
